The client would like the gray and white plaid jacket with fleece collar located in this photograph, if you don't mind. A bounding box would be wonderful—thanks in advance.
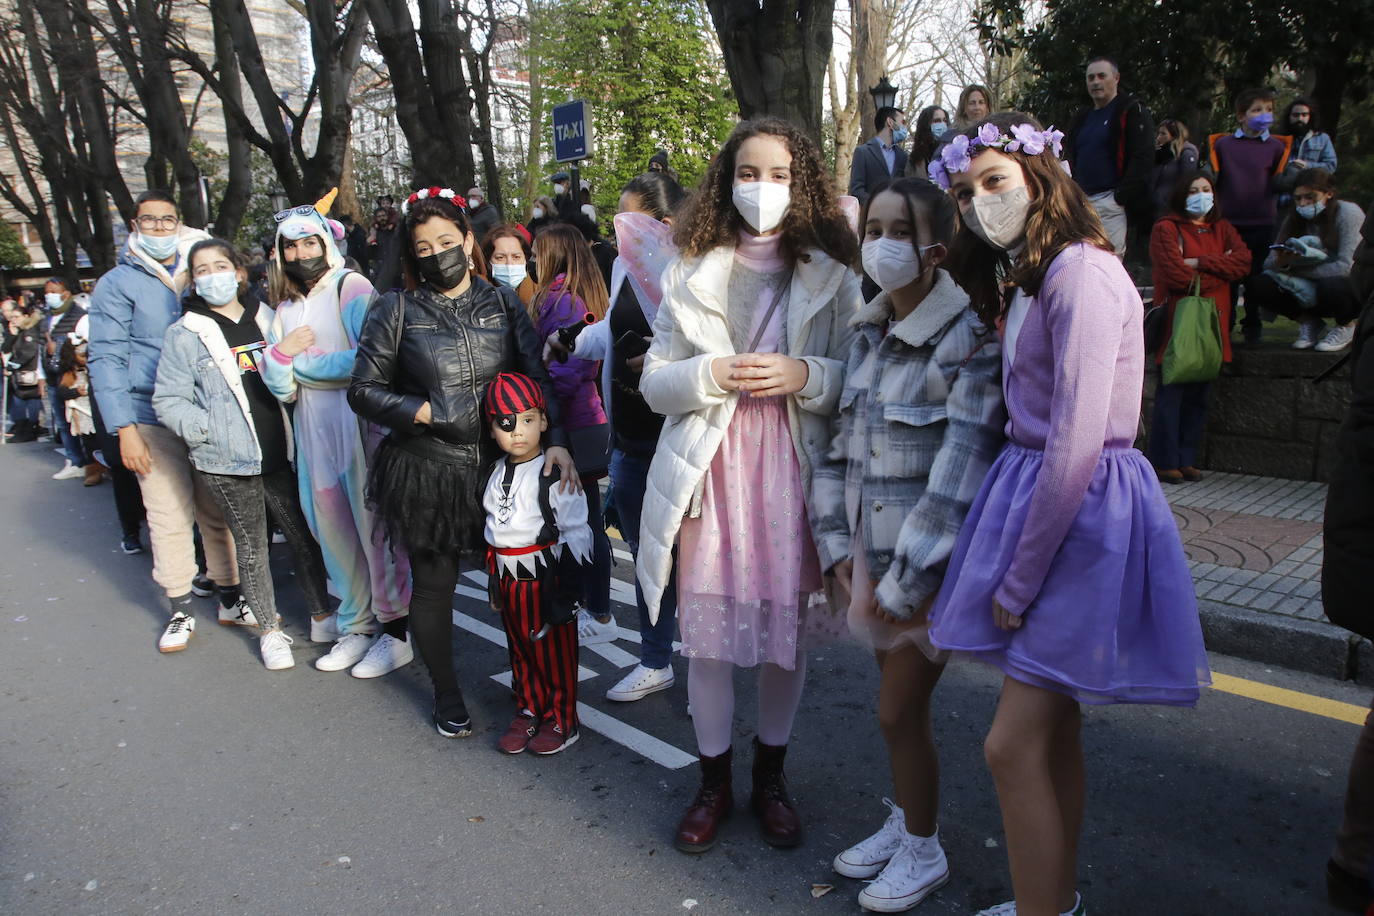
[811,271,1006,619]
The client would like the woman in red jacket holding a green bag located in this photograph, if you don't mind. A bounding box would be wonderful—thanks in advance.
[1149,172,1250,483]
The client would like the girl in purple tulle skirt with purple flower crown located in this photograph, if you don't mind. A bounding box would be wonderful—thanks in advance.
[930,113,1210,916]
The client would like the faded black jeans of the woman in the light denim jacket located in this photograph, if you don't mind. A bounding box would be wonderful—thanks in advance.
[196,468,330,630]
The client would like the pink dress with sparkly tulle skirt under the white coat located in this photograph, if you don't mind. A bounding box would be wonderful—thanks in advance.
[677,236,834,670]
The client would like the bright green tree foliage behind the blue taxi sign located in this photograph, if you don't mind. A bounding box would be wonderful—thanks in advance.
[541,0,736,227]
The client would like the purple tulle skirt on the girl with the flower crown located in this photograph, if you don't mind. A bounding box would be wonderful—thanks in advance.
[930,444,1212,706]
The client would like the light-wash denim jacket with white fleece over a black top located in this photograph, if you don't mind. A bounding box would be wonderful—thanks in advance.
[153,305,294,477]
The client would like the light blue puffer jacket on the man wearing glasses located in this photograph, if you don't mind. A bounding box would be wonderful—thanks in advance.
[89,227,210,434]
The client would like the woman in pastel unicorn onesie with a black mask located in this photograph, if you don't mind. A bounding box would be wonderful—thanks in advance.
[262,195,414,677]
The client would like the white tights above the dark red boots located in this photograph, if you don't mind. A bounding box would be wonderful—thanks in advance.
[687,652,807,757]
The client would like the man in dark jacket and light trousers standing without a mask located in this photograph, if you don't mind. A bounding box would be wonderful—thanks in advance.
[1063,56,1154,257]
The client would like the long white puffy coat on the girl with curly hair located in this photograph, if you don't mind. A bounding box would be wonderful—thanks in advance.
[636,246,863,621]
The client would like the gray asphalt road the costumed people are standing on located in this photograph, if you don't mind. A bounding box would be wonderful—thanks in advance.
[0,445,1370,916]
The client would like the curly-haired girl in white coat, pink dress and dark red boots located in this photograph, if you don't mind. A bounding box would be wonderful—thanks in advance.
[639,118,861,853]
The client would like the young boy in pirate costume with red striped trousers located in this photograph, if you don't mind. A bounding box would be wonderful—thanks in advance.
[482,372,592,754]
